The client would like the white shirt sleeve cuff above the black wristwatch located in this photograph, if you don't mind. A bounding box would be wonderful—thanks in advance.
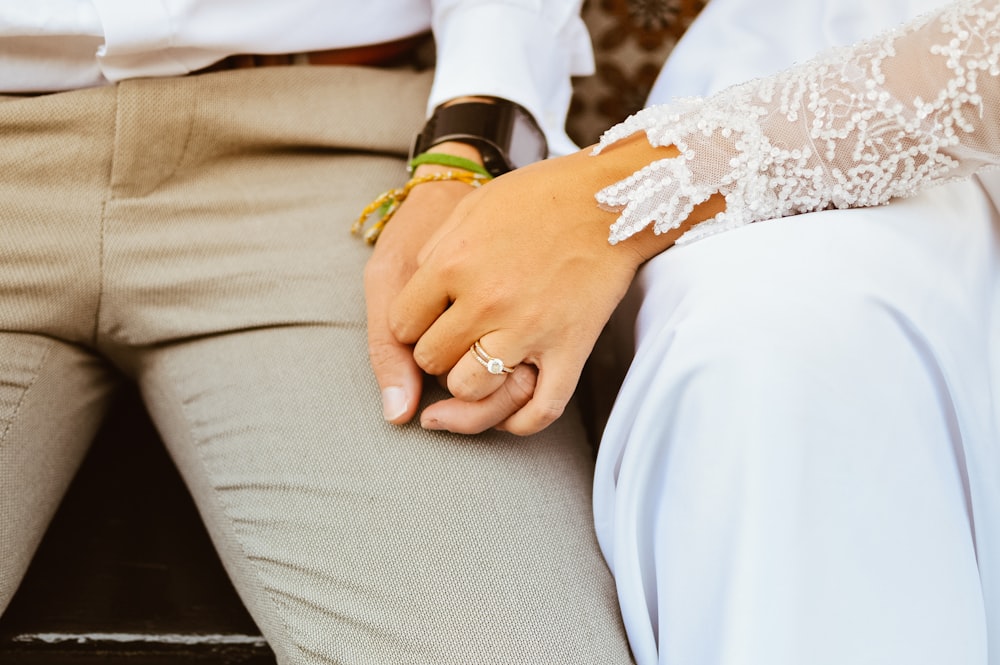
[428,0,594,155]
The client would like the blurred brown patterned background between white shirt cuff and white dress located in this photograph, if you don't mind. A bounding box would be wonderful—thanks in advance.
[567,0,708,146]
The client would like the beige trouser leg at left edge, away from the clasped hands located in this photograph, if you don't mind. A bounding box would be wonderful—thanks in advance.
[0,92,121,612]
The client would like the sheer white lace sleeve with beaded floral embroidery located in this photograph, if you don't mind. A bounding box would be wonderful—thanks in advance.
[594,0,1000,244]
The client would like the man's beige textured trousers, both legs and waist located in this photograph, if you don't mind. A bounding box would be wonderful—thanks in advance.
[0,67,630,665]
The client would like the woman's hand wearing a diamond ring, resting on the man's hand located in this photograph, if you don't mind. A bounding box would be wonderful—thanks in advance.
[389,136,718,434]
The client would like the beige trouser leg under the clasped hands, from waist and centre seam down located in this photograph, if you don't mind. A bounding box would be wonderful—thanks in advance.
[90,68,630,665]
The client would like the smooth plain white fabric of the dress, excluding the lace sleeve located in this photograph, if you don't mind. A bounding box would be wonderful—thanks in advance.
[594,0,1000,665]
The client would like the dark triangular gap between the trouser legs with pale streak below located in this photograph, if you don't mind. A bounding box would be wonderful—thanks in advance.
[0,392,274,665]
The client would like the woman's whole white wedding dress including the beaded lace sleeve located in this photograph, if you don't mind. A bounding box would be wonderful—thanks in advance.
[594,0,1000,665]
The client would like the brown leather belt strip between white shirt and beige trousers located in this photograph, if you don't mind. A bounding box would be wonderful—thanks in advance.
[192,33,431,74]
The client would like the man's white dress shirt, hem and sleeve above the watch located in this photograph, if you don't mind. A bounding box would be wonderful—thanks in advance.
[0,0,593,154]
